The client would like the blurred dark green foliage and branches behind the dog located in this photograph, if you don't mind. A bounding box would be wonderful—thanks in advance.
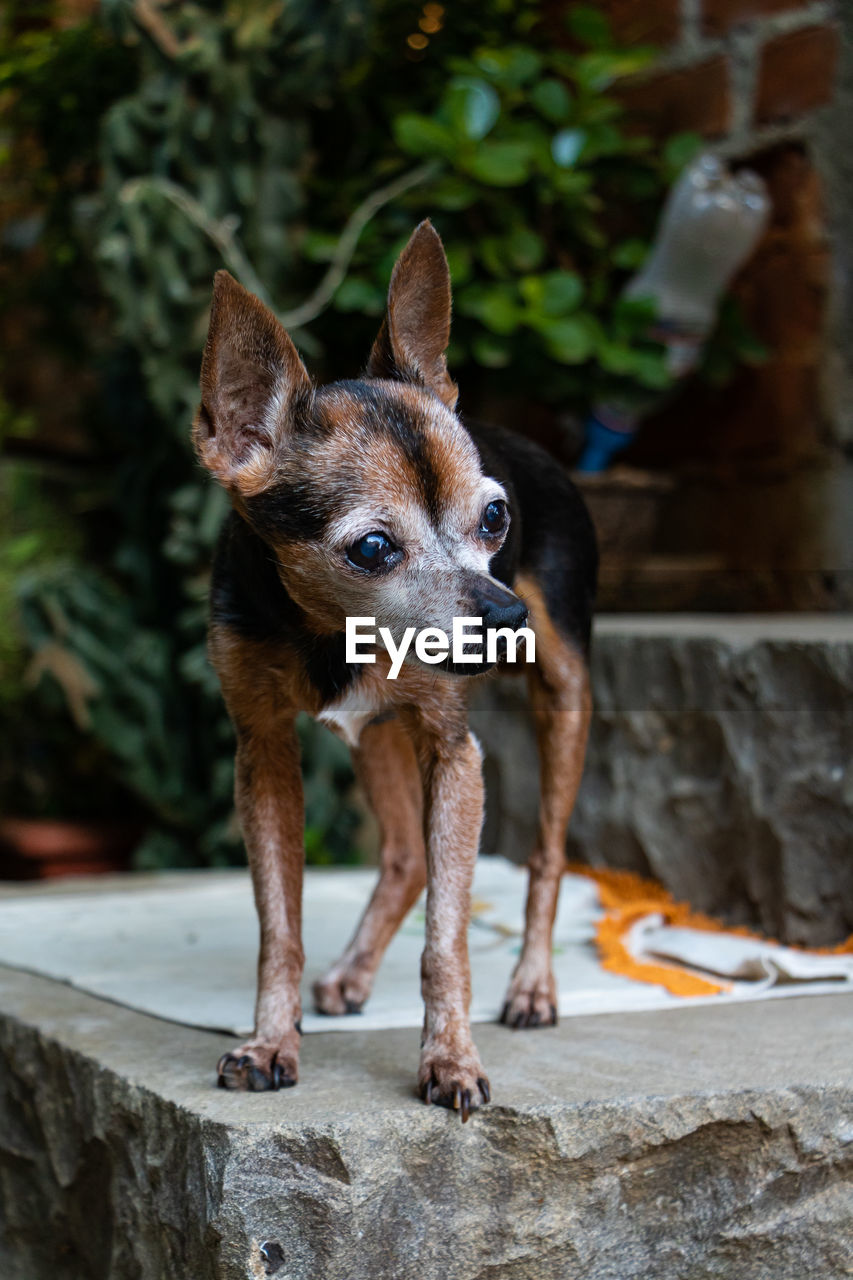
[0,0,758,865]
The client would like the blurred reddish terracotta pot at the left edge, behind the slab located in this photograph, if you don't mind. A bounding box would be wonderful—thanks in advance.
[0,818,142,879]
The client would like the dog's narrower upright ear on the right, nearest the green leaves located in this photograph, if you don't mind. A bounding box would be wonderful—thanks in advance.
[366,219,459,408]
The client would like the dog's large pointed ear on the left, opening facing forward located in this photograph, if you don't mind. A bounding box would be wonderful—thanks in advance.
[192,271,311,497]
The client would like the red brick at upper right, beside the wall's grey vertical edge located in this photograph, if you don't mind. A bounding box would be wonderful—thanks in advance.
[756,26,839,124]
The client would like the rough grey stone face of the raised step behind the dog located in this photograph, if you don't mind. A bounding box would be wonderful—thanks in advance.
[473,616,853,946]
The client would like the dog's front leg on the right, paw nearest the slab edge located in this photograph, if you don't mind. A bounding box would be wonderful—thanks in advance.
[418,732,489,1120]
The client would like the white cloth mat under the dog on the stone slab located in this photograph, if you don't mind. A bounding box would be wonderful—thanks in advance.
[0,858,853,1036]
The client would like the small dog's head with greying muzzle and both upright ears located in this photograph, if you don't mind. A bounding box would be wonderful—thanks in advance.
[193,221,526,673]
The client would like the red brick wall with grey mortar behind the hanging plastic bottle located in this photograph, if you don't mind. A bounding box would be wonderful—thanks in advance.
[548,0,853,612]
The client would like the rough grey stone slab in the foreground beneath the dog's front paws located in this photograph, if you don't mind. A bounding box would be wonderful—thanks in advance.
[0,969,853,1280]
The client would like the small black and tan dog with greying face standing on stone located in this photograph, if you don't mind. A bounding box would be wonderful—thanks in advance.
[193,221,597,1121]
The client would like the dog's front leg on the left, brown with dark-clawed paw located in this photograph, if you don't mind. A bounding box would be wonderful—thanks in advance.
[218,721,305,1092]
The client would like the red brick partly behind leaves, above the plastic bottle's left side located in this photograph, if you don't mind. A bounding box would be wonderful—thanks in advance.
[619,56,731,138]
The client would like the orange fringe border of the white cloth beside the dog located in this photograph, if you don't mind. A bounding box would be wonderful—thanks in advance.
[569,863,853,996]
